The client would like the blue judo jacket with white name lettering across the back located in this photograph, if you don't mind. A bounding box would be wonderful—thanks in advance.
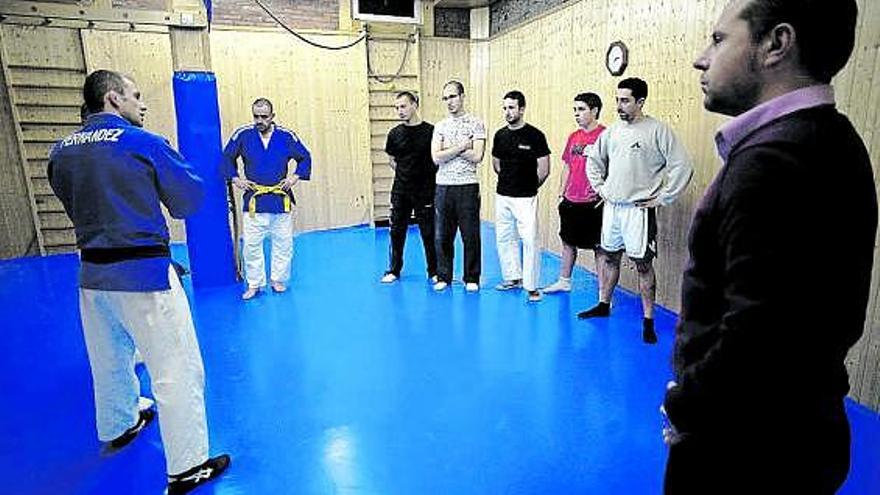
[48,113,204,292]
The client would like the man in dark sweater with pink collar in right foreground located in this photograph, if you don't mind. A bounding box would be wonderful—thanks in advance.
[663,0,877,494]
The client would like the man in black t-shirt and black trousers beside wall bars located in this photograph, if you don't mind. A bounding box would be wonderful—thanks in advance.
[382,91,437,284]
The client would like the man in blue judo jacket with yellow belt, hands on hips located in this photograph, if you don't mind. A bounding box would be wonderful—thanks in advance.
[223,98,312,300]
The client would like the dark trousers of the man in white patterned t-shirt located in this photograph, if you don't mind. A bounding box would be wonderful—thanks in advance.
[434,184,480,283]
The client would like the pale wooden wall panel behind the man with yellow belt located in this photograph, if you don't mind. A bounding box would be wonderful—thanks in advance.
[211,29,371,231]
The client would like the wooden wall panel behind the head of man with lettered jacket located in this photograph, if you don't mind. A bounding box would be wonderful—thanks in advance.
[81,29,186,242]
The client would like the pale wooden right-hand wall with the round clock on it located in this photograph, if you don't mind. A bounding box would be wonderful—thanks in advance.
[474,0,880,409]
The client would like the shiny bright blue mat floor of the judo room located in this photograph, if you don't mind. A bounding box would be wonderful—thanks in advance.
[0,225,880,495]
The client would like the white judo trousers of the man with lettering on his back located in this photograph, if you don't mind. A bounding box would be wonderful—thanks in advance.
[79,268,208,474]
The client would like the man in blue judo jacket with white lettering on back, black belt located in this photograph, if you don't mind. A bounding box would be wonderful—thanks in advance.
[48,70,230,495]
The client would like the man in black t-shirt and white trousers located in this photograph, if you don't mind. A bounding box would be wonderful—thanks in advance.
[492,91,550,302]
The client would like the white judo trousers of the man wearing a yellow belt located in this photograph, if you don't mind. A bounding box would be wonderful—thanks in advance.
[242,213,293,289]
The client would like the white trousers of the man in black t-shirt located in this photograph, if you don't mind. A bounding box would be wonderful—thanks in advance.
[495,194,541,290]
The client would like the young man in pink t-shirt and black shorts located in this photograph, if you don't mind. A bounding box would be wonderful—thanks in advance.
[544,93,605,294]
